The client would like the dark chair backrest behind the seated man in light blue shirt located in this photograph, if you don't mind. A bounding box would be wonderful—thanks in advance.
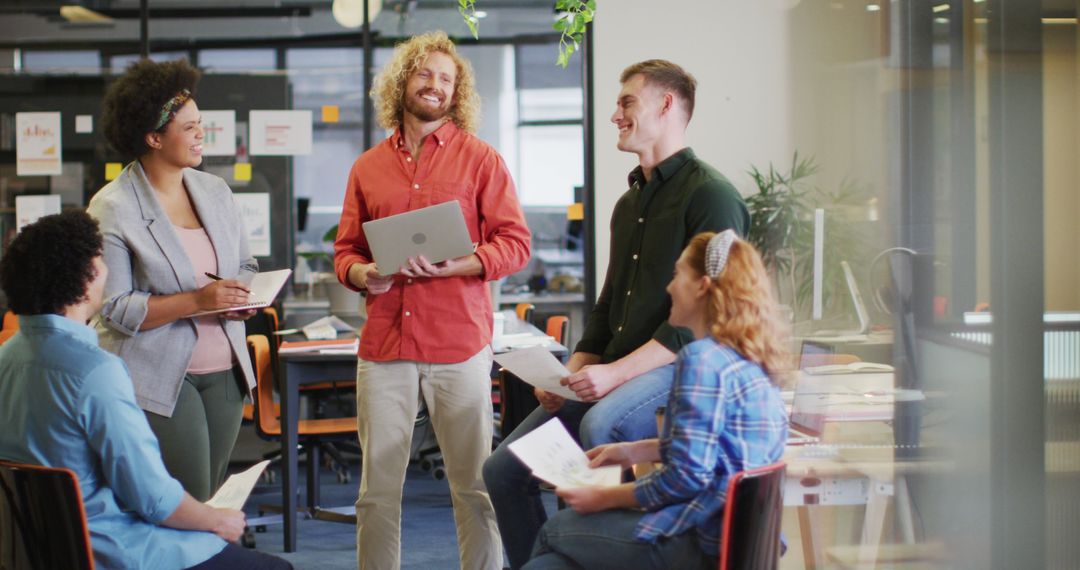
[0,461,94,570]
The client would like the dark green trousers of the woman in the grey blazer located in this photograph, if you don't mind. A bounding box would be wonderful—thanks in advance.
[146,368,244,501]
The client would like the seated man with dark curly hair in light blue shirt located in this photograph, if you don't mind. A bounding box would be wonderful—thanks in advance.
[0,212,292,570]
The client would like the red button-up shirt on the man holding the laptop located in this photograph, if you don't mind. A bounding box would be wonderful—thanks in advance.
[334,122,530,364]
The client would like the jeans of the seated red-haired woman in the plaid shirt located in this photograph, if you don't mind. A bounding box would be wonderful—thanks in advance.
[524,508,717,570]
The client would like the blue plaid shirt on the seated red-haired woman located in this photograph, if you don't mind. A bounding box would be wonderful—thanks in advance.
[634,337,787,554]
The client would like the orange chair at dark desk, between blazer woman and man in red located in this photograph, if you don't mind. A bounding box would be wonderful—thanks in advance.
[247,335,356,508]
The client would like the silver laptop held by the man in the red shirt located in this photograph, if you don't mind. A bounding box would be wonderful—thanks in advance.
[363,200,473,275]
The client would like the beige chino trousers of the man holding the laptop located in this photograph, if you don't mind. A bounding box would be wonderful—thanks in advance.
[356,347,502,570]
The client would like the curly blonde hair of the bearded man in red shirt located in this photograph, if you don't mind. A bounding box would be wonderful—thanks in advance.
[372,31,480,133]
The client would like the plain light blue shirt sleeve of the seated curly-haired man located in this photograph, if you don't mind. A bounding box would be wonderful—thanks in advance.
[79,357,184,524]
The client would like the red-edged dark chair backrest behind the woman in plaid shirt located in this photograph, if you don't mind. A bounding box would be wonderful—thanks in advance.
[720,462,786,570]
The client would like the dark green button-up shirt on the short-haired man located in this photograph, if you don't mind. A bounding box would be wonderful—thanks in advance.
[575,148,750,363]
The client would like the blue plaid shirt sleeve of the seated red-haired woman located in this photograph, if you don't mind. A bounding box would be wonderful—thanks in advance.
[634,344,725,511]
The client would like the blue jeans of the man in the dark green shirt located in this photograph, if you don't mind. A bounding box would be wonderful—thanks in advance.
[484,364,675,568]
